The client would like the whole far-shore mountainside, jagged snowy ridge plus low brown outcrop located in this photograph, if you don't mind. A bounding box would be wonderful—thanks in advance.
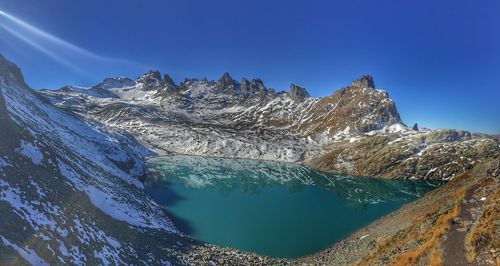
[40,71,500,180]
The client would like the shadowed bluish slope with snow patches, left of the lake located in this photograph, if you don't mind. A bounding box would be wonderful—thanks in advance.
[0,56,282,265]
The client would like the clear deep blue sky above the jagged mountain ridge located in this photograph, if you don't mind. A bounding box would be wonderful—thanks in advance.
[0,0,500,133]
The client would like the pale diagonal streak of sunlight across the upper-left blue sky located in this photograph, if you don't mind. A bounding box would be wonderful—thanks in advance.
[0,10,144,74]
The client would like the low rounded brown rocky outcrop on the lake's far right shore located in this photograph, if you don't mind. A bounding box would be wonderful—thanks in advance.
[310,131,500,180]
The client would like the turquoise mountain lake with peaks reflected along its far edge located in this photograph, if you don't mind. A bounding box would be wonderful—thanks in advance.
[144,156,435,258]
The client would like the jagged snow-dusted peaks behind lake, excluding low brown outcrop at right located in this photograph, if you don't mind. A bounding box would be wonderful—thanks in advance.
[41,71,406,162]
